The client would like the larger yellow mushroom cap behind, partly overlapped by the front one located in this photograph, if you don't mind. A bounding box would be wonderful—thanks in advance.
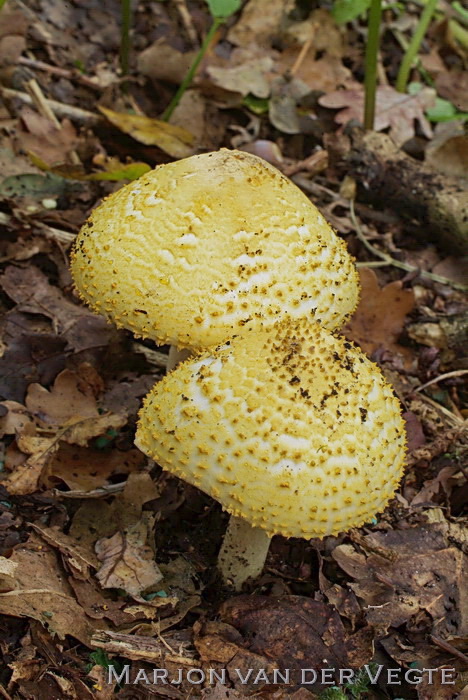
[71,149,359,349]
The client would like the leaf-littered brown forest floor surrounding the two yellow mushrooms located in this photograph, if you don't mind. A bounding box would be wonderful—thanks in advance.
[0,0,468,700]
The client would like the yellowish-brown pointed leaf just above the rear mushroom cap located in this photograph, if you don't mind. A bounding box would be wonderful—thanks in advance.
[99,107,194,158]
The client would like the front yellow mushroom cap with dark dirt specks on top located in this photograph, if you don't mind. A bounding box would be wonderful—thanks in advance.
[136,320,405,537]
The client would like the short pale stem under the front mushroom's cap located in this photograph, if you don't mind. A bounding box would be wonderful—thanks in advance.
[218,515,271,591]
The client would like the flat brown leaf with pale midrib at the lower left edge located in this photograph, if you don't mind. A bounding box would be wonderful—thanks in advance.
[0,535,106,645]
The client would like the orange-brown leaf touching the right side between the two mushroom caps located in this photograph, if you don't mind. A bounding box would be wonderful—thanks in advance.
[343,267,415,361]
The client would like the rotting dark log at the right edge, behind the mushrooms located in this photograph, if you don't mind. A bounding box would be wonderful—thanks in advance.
[346,128,468,254]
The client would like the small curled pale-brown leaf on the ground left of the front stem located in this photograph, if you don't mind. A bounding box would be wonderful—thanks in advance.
[96,520,162,596]
